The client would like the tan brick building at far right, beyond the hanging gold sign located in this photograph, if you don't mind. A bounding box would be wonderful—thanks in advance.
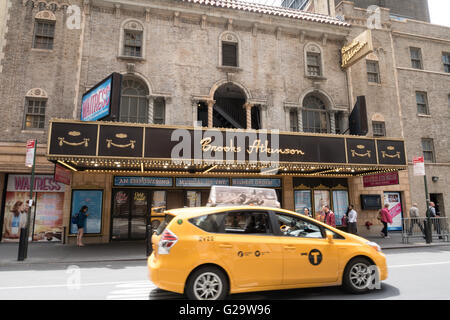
[336,1,450,215]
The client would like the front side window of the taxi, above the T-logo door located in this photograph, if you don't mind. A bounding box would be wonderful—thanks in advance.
[275,213,324,238]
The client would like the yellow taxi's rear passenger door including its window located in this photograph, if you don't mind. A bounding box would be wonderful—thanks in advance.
[214,210,283,288]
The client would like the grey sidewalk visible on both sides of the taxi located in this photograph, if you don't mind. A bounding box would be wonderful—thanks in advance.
[0,232,450,268]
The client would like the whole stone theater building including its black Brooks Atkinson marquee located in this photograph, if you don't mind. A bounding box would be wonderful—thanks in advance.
[4,0,440,243]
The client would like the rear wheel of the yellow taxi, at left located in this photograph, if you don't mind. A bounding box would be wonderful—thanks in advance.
[185,266,229,300]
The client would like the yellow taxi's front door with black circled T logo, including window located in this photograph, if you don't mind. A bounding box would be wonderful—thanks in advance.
[276,213,338,285]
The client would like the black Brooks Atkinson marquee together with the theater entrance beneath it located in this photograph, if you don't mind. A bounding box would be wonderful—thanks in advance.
[47,120,407,242]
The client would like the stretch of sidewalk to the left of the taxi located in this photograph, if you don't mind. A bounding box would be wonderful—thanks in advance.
[0,241,146,267]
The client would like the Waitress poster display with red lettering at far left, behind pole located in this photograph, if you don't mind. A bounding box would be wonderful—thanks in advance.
[2,174,65,242]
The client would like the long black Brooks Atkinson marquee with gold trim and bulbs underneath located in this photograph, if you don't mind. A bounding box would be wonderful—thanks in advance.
[47,120,407,176]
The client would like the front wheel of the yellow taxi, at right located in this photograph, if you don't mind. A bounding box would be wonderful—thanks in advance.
[342,257,374,294]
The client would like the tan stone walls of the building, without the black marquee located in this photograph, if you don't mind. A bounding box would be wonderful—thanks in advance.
[0,0,450,242]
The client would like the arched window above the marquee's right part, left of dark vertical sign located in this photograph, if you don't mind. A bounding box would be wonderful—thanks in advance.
[302,95,330,133]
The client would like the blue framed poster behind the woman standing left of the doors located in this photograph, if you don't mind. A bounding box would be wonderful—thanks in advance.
[70,190,103,234]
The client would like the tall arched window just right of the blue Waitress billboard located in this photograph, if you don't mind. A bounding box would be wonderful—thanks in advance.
[120,78,148,123]
